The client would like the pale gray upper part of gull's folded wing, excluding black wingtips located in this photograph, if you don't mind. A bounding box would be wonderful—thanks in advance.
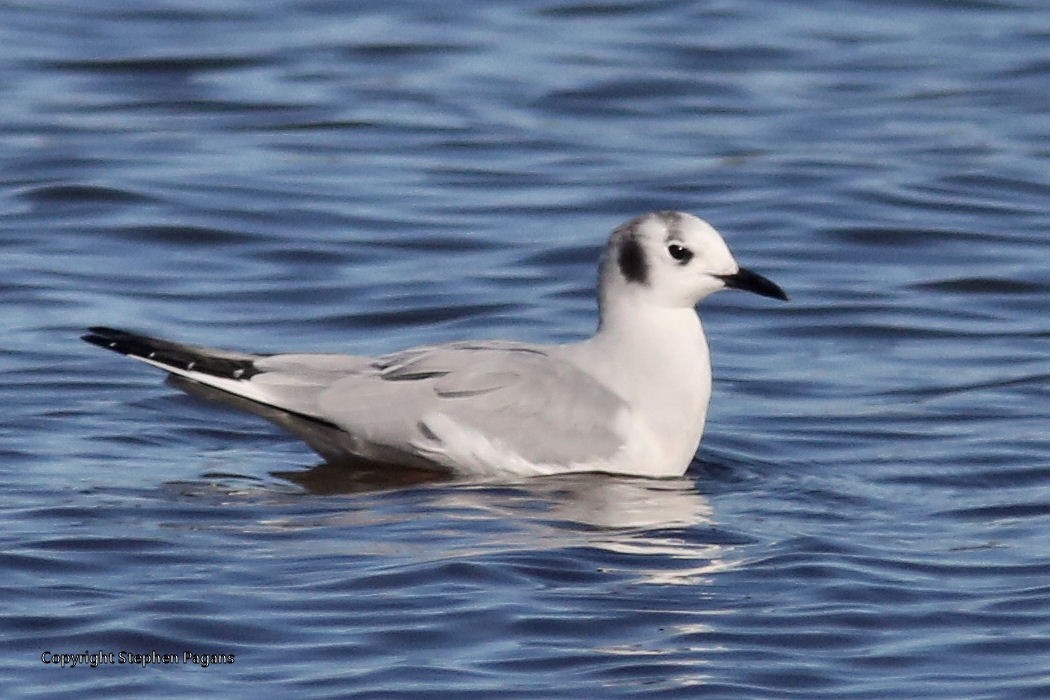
[318,342,627,466]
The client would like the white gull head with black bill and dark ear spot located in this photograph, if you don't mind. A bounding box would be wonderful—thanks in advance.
[601,211,788,309]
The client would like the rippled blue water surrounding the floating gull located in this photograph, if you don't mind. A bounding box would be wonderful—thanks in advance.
[0,0,1050,699]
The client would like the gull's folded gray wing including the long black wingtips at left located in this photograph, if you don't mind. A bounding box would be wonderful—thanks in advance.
[84,327,627,469]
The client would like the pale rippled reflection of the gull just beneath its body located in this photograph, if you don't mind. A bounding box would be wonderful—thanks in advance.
[172,464,729,584]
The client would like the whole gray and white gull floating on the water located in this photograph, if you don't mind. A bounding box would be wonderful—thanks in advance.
[83,211,788,478]
